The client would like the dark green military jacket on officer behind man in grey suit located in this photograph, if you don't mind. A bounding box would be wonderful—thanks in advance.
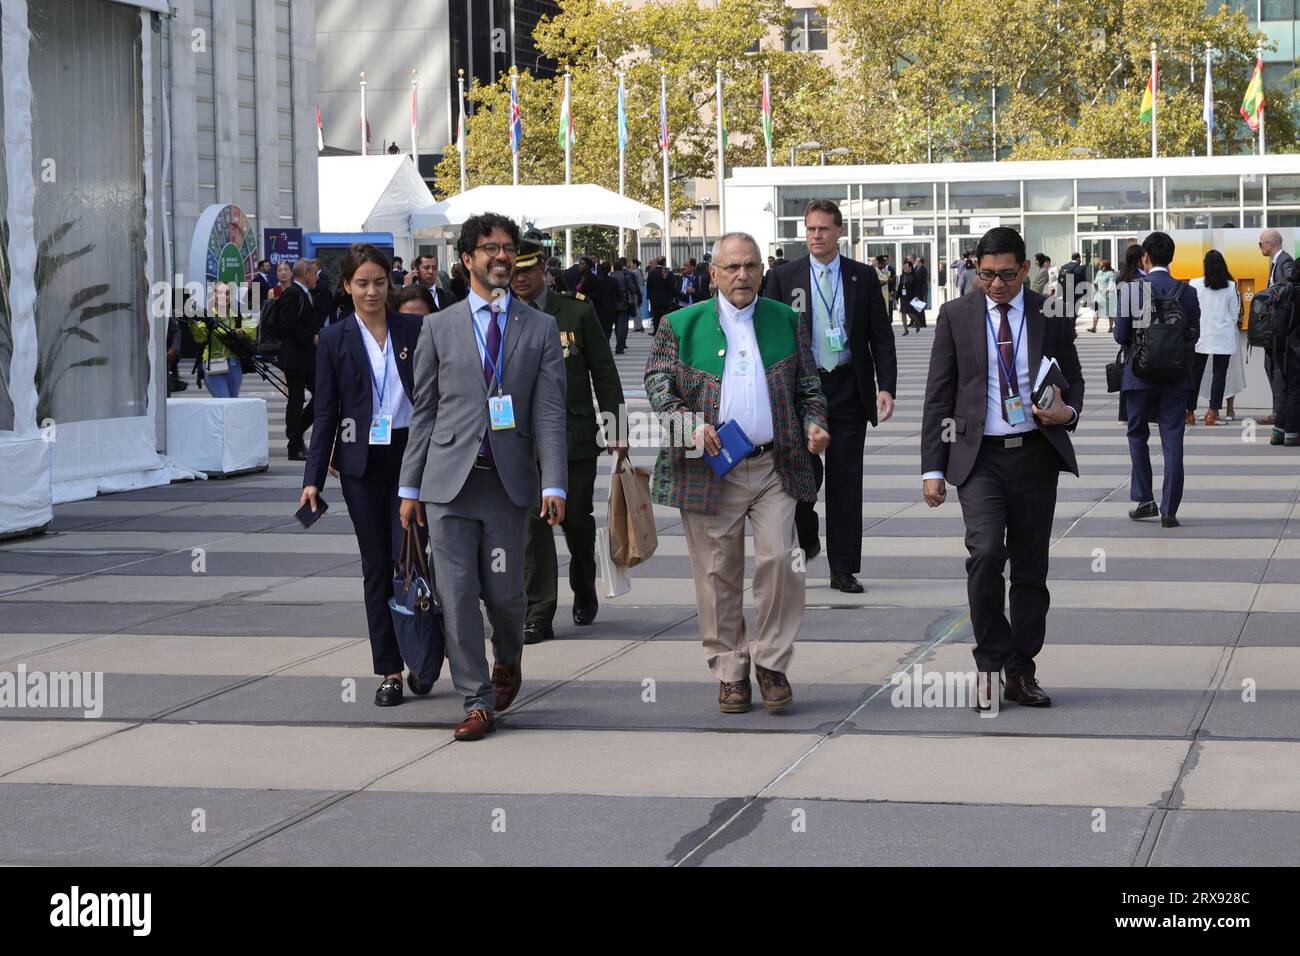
[533,289,625,459]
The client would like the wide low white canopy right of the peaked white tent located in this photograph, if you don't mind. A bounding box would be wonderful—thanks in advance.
[411,182,663,233]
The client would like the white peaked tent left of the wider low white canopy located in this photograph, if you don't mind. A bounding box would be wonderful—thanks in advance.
[317,153,433,259]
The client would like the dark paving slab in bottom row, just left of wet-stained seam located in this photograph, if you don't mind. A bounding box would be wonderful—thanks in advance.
[228,792,740,866]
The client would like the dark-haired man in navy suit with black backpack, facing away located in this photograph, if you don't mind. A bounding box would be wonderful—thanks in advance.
[1114,233,1201,528]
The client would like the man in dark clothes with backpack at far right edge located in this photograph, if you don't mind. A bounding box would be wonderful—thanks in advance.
[1247,229,1300,447]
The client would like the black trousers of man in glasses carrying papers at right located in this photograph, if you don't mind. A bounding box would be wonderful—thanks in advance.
[957,433,1061,678]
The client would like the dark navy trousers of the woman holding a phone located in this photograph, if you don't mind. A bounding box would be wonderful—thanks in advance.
[339,428,416,674]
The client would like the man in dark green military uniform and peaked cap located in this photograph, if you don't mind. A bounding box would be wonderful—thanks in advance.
[511,239,628,644]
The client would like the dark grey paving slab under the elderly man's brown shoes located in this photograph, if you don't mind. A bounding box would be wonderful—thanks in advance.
[507,681,866,734]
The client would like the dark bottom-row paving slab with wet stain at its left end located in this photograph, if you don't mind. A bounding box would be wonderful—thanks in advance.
[686,799,1153,866]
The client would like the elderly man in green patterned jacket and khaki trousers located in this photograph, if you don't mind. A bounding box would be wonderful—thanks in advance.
[645,233,831,714]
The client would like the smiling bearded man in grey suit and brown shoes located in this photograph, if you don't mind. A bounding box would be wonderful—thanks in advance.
[398,212,568,740]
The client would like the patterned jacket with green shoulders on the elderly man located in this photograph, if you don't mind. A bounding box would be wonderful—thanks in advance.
[645,298,827,514]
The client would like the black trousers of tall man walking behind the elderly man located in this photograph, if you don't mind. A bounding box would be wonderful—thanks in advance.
[794,364,867,574]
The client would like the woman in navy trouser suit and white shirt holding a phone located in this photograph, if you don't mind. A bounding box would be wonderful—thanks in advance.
[299,243,429,706]
